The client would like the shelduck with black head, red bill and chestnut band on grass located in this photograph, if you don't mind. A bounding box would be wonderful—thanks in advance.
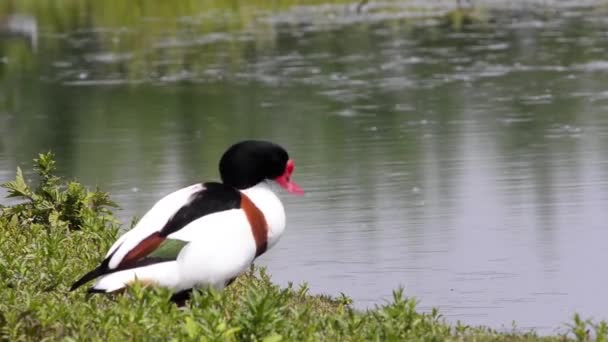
[70,140,304,304]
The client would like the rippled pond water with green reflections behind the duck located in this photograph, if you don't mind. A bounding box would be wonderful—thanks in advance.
[0,2,608,333]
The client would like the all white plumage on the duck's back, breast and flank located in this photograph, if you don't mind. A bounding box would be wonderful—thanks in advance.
[93,182,285,292]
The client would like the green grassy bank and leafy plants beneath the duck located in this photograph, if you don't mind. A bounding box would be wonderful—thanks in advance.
[0,153,608,342]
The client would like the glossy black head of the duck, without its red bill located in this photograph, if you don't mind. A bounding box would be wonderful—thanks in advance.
[220,140,289,189]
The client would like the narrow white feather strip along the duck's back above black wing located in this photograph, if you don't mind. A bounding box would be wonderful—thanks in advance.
[106,184,204,269]
